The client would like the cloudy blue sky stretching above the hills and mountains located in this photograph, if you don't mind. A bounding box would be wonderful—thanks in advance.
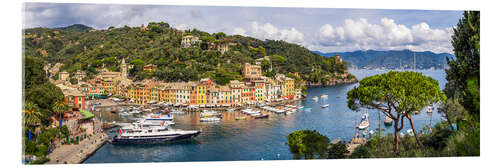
[23,3,462,53]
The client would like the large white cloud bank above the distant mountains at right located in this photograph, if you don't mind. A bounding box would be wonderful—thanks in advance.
[315,18,453,52]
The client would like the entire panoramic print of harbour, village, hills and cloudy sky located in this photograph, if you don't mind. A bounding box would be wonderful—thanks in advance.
[21,3,480,164]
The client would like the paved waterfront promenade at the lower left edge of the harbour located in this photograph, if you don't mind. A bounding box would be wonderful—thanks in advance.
[47,120,108,164]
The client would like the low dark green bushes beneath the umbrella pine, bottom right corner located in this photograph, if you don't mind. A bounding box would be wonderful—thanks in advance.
[350,119,479,158]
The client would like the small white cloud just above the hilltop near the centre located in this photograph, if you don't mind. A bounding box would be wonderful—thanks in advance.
[233,21,304,44]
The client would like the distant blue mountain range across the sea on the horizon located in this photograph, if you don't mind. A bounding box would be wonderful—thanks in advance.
[313,49,455,69]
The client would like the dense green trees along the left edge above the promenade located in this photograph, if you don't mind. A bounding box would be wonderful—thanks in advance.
[22,56,69,160]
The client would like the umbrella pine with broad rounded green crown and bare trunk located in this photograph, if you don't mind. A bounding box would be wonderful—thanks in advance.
[347,71,446,152]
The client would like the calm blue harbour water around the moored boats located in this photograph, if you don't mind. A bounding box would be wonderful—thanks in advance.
[84,70,446,163]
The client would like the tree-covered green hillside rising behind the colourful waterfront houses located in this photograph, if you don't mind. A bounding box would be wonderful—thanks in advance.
[24,22,346,84]
